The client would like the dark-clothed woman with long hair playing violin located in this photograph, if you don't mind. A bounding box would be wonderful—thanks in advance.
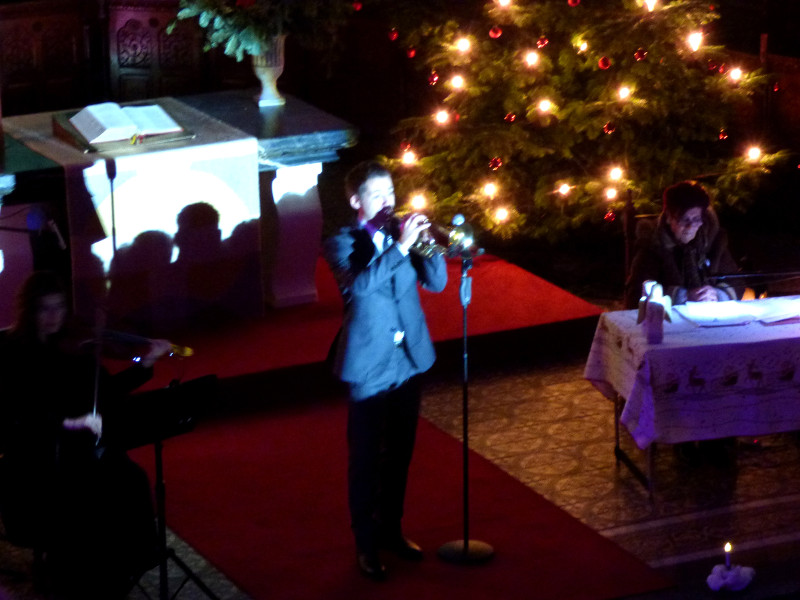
[0,272,170,600]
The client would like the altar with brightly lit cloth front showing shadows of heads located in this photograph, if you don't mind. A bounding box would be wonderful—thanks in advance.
[0,90,355,331]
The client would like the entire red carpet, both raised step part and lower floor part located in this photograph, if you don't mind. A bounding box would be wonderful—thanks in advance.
[125,256,665,600]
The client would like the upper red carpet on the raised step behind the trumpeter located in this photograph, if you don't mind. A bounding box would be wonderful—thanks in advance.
[144,255,602,387]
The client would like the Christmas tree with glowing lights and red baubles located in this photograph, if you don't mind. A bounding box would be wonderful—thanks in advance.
[378,0,782,239]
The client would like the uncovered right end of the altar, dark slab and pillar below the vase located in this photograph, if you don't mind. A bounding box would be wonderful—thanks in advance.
[181,90,356,308]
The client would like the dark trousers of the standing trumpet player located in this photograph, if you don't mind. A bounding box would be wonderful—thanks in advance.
[347,377,420,553]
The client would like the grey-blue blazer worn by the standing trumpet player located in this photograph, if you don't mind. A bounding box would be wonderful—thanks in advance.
[324,227,447,392]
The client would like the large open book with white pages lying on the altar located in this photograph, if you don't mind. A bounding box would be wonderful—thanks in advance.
[69,102,183,144]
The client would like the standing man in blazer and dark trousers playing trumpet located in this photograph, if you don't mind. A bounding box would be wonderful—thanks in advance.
[325,162,447,580]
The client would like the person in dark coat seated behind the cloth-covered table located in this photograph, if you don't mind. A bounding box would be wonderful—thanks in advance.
[625,181,740,308]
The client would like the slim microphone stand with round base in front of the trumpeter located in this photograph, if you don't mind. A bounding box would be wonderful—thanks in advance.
[437,249,494,565]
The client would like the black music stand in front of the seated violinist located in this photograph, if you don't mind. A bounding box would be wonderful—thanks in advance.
[126,375,220,600]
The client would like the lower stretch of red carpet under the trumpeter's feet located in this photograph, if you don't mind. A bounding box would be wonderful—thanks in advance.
[133,399,665,600]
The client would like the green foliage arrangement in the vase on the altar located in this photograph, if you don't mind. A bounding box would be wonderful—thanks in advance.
[170,0,353,61]
